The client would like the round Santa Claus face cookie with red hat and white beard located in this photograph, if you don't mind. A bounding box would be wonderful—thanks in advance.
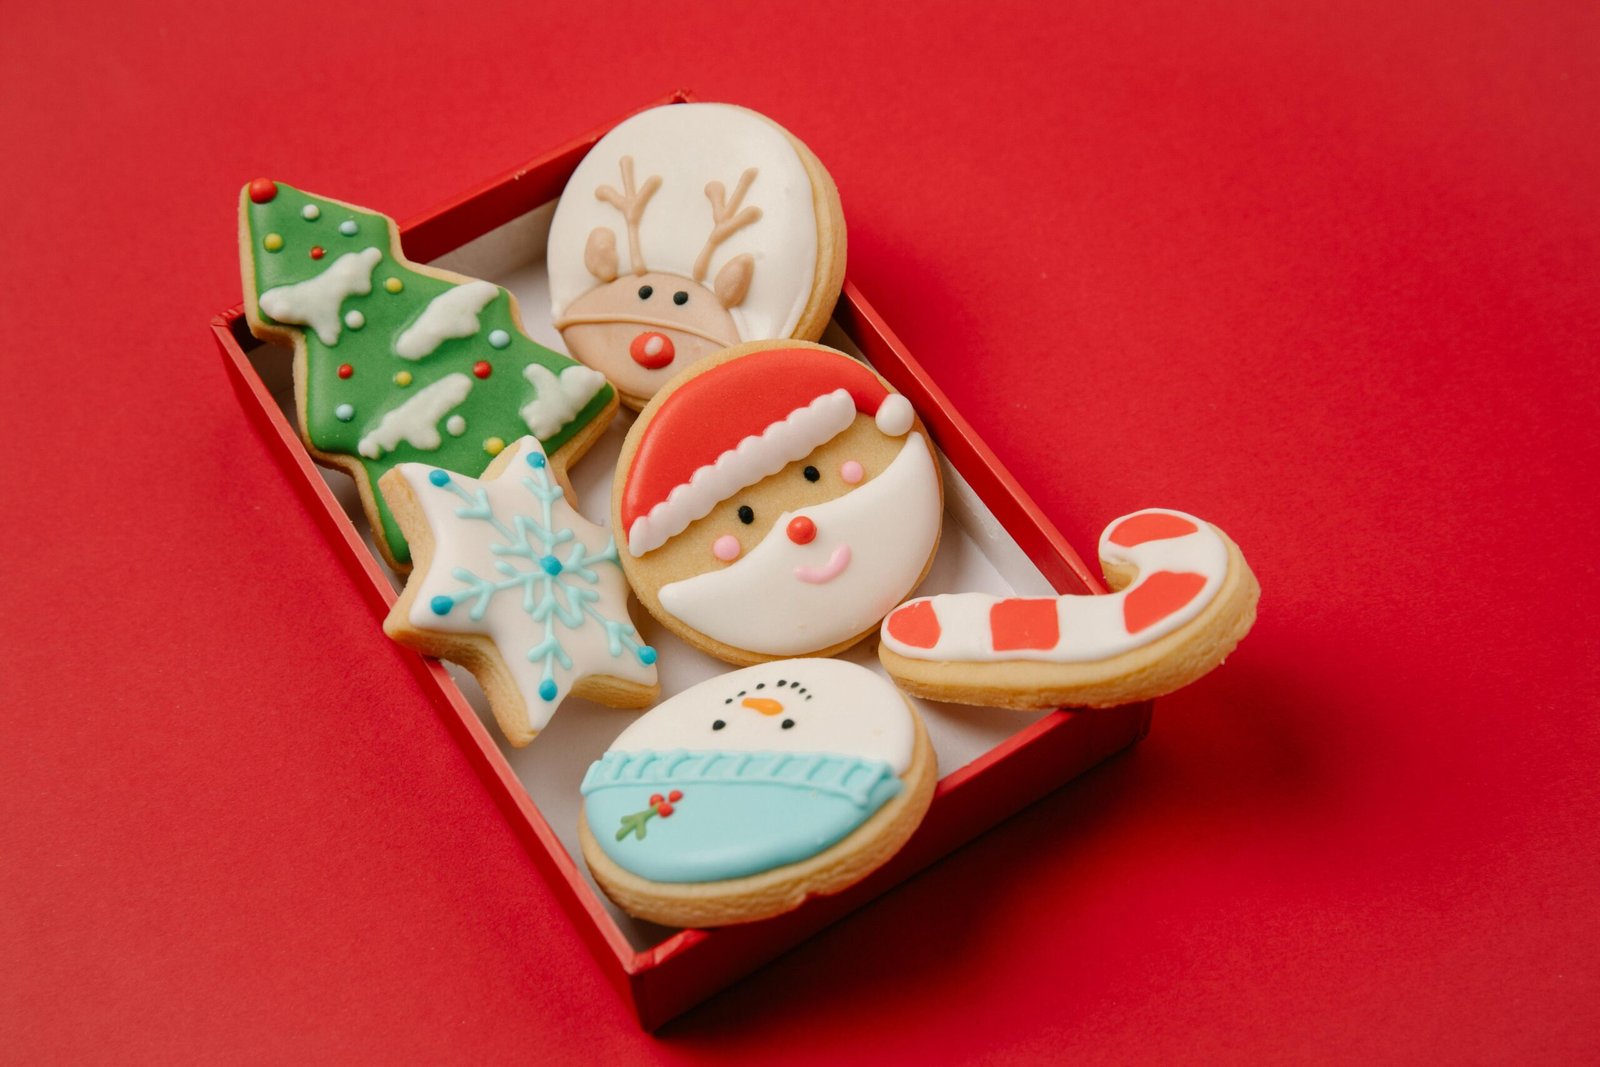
[613,341,944,664]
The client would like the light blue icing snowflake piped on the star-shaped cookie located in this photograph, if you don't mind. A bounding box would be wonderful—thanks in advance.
[427,453,656,704]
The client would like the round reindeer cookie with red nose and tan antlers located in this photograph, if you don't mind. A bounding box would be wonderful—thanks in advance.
[547,104,845,408]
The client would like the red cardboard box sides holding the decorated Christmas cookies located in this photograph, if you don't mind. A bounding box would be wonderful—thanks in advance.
[211,91,1152,1029]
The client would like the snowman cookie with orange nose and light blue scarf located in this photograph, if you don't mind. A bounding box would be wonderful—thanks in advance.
[579,659,938,926]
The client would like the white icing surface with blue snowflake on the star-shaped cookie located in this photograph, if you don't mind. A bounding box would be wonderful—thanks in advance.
[397,437,656,729]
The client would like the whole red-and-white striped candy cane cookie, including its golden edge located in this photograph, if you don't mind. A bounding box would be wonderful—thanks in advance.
[878,509,1261,707]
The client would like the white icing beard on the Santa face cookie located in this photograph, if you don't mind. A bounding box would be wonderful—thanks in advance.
[661,434,942,656]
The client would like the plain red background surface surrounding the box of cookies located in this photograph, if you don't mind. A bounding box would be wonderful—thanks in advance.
[0,0,1600,1062]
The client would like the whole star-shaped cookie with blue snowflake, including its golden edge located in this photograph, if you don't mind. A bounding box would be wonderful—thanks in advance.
[379,437,661,747]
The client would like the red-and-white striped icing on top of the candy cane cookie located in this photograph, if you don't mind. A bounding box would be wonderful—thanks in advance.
[882,509,1229,664]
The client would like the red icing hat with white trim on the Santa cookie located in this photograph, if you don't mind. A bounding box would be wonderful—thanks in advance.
[622,349,915,557]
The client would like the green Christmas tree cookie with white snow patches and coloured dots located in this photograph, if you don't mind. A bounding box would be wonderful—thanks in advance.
[238,178,616,573]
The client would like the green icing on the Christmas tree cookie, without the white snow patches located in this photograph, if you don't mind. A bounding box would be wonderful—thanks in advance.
[242,182,614,563]
